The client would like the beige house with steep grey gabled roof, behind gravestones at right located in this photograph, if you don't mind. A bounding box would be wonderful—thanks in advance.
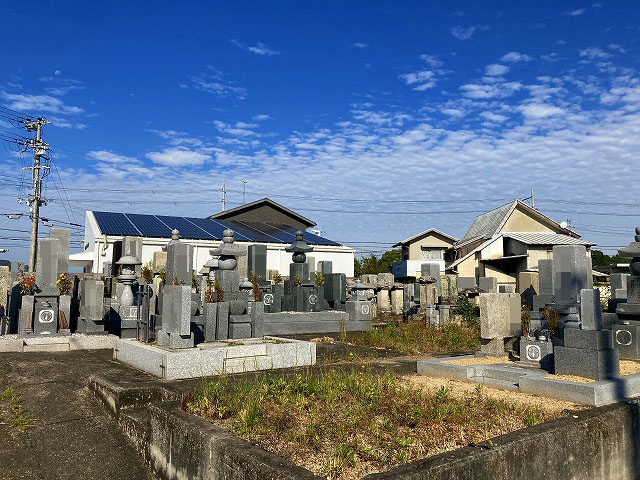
[447,200,595,285]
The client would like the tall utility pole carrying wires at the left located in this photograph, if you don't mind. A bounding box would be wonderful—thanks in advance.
[25,117,51,272]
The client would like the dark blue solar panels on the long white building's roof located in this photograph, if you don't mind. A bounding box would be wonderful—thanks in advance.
[93,212,340,246]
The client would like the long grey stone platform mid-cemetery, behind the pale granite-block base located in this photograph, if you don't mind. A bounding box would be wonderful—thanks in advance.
[264,310,371,335]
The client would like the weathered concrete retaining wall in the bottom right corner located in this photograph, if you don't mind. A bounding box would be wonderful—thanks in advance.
[364,403,640,480]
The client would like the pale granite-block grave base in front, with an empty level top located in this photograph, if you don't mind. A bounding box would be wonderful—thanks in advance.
[113,336,316,380]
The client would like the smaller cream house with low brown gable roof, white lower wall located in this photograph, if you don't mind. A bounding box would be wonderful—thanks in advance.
[392,228,456,277]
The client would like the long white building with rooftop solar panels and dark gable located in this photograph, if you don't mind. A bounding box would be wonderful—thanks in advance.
[70,198,354,277]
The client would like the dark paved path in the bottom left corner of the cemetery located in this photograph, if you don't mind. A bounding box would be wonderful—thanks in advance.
[0,350,154,480]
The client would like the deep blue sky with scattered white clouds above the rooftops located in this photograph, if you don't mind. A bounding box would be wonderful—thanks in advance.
[0,1,640,258]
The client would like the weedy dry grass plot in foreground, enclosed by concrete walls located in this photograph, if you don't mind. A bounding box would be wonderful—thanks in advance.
[184,366,570,480]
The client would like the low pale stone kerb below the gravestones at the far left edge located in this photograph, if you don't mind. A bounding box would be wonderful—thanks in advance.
[0,333,118,353]
